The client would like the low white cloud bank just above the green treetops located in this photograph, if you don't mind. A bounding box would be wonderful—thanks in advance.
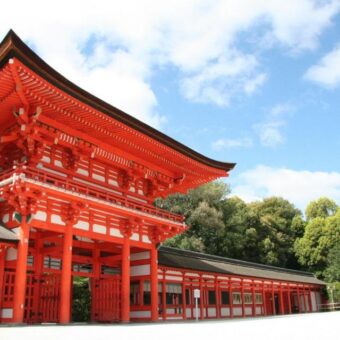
[232,165,340,209]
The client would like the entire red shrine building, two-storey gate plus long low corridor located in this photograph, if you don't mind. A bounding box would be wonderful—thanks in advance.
[0,31,323,324]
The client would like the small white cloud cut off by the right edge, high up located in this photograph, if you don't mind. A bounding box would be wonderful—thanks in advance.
[305,46,340,88]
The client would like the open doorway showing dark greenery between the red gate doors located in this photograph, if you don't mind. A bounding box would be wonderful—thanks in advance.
[72,276,91,322]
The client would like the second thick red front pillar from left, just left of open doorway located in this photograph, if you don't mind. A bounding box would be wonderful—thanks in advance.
[59,225,73,324]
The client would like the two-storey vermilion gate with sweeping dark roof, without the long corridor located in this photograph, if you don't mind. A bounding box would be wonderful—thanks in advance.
[0,32,234,323]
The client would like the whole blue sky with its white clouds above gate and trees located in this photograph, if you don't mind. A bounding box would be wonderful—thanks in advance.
[0,0,340,209]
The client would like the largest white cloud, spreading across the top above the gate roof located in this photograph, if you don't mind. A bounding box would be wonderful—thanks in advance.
[0,0,340,122]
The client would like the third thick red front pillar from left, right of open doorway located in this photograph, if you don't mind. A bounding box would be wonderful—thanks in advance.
[121,233,130,322]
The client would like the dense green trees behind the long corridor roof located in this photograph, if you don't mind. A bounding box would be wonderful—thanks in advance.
[156,182,340,298]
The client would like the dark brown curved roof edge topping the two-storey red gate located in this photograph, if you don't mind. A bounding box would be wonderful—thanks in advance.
[0,30,236,172]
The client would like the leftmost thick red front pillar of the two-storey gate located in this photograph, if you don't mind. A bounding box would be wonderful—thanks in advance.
[13,215,30,323]
